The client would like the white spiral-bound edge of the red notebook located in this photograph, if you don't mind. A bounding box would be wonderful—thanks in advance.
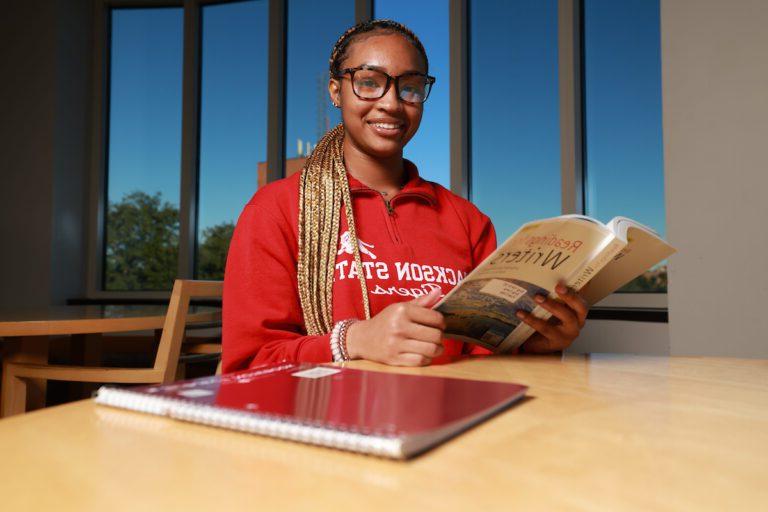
[95,388,406,459]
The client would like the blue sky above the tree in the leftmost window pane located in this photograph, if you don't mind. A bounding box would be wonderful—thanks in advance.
[107,9,183,209]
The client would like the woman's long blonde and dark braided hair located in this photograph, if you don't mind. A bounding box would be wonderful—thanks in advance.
[297,20,428,334]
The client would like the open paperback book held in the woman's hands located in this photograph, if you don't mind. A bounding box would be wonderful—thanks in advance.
[434,215,675,352]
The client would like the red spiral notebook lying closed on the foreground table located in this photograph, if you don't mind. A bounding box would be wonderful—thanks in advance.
[95,363,527,459]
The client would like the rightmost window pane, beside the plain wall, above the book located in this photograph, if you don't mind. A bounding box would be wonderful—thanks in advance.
[584,0,667,292]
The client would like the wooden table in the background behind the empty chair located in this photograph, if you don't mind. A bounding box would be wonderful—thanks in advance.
[0,305,221,414]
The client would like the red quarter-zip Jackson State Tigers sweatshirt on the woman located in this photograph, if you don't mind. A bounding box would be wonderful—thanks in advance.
[223,162,496,372]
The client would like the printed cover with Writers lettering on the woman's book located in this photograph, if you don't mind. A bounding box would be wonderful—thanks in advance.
[435,217,615,352]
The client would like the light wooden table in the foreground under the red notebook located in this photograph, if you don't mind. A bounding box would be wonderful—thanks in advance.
[0,355,768,512]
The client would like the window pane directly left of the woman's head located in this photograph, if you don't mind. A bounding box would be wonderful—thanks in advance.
[282,0,355,175]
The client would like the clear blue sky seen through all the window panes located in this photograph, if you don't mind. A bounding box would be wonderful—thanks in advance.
[108,0,664,244]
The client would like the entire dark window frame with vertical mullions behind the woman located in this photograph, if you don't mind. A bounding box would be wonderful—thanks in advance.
[86,0,667,312]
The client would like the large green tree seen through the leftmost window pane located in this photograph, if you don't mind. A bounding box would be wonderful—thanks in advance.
[105,191,179,290]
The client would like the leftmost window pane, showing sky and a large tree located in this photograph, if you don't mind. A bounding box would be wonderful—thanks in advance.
[103,8,183,290]
